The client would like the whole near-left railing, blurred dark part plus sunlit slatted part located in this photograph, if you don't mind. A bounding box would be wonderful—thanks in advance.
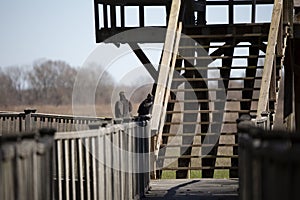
[0,118,151,200]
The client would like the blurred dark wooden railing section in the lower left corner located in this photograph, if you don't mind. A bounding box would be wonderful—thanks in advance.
[0,130,54,200]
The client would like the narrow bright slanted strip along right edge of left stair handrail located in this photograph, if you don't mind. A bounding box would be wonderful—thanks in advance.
[154,22,182,156]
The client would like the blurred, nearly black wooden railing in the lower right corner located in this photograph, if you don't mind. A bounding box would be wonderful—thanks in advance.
[238,121,300,200]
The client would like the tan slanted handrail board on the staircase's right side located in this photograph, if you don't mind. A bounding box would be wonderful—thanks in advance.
[257,0,282,119]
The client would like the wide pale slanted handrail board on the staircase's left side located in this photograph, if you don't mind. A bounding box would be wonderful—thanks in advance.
[151,0,181,131]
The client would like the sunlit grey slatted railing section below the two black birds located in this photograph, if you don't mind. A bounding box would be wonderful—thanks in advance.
[54,122,150,200]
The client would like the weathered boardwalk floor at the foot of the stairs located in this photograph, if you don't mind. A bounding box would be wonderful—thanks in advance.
[142,179,239,200]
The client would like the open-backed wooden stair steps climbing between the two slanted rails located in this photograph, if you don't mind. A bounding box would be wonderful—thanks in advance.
[157,24,280,178]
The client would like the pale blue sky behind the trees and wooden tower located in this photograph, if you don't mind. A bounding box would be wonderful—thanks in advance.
[0,0,272,79]
